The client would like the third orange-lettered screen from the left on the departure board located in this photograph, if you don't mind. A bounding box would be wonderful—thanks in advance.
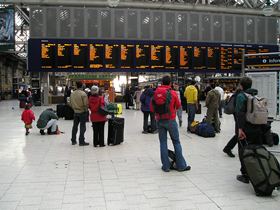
[72,44,89,69]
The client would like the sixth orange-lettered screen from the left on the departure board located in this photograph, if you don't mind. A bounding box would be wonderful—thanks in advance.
[121,44,135,69]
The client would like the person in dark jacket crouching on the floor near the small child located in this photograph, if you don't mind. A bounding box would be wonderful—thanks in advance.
[37,108,59,135]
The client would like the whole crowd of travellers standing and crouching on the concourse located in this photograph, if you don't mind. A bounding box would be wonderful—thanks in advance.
[22,76,276,191]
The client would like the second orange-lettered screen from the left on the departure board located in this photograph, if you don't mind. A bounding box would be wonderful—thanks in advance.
[56,44,72,69]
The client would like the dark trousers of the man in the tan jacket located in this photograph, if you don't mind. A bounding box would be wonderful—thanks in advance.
[71,112,88,144]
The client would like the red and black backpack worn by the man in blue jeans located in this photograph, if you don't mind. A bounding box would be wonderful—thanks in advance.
[152,89,172,115]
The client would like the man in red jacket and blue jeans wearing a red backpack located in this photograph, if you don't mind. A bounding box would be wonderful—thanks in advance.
[151,76,191,172]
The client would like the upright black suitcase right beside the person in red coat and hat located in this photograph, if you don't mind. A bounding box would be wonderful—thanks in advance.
[107,117,124,145]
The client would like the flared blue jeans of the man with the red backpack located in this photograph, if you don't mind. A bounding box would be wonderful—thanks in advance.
[158,120,187,170]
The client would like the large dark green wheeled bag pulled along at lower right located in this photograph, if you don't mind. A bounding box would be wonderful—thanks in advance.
[241,145,280,196]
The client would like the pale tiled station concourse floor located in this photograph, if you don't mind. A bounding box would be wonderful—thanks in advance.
[0,101,280,210]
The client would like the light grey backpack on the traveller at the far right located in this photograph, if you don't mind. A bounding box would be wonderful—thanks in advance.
[244,93,268,125]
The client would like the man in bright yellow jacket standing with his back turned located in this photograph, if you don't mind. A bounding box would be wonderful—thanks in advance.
[184,81,198,131]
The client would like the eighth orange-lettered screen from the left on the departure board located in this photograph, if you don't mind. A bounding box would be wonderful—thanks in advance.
[150,45,165,69]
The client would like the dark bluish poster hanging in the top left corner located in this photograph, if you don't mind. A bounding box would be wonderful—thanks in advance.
[0,7,15,51]
